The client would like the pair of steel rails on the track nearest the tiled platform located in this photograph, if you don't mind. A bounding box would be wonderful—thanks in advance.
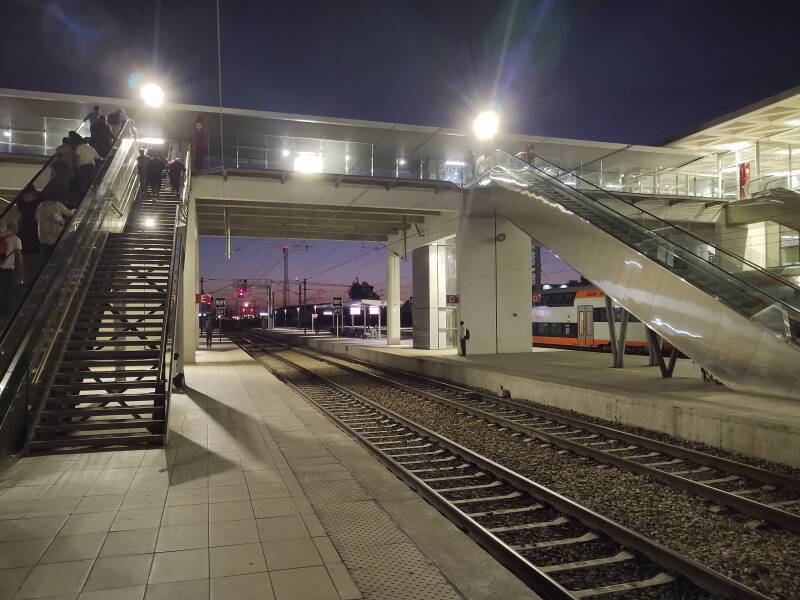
[231,336,767,599]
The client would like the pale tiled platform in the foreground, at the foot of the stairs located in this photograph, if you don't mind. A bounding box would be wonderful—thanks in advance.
[0,341,537,600]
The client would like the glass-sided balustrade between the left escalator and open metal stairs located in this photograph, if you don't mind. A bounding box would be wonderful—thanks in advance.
[0,121,138,453]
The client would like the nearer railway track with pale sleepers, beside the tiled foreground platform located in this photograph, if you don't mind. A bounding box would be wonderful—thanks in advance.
[232,335,766,599]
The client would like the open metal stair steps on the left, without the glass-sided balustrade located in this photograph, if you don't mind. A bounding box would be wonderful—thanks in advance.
[28,171,181,451]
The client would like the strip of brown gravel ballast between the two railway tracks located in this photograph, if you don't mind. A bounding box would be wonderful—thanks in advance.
[264,352,800,598]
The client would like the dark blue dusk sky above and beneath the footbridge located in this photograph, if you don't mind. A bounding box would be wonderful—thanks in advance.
[0,0,800,304]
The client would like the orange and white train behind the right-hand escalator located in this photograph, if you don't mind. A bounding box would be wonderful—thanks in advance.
[533,286,647,354]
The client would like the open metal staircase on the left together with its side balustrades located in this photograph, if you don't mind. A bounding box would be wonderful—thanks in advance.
[0,125,190,453]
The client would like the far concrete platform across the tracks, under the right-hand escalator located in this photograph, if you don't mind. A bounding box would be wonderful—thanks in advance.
[260,329,800,467]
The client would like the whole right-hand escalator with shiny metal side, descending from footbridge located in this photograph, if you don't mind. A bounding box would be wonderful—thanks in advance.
[472,151,800,398]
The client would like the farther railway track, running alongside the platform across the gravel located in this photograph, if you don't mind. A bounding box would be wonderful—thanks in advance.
[250,330,800,533]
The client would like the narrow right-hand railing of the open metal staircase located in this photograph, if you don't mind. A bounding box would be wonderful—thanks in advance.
[159,151,192,446]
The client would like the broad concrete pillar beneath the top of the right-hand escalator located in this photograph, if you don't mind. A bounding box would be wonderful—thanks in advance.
[456,215,532,354]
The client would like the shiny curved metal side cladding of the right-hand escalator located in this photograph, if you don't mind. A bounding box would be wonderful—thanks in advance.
[467,186,800,398]
